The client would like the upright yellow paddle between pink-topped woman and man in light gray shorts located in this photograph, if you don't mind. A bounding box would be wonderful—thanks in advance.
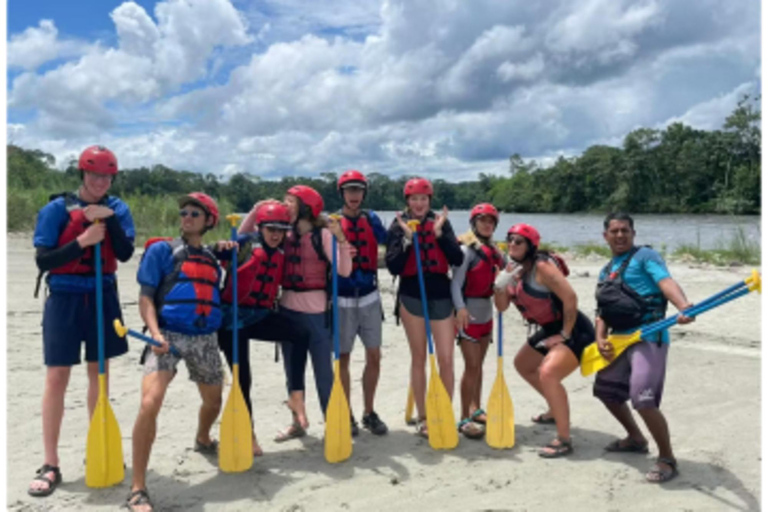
[325,216,352,464]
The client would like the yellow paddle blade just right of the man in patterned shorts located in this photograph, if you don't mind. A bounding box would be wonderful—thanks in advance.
[219,364,253,473]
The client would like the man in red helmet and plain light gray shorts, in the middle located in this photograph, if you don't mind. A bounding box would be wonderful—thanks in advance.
[337,170,387,436]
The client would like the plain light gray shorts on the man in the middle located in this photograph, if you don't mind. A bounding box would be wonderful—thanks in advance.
[339,292,383,354]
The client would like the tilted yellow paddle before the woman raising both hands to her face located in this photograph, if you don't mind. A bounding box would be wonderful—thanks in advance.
[408,220,459,450]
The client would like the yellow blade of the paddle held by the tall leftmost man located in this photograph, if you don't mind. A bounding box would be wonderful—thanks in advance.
[85,374,125,488]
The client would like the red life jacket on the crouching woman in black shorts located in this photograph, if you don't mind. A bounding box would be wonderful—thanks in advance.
[507,251,570,325]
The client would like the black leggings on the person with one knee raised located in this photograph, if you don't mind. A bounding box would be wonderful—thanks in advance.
[218,311,309,422]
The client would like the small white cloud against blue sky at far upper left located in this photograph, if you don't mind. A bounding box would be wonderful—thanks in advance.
[7,20,88,70]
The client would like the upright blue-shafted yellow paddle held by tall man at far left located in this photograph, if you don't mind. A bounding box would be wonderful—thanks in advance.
[85,232,125,488]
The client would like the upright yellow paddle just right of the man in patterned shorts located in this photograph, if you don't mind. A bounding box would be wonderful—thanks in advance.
[219,214,253,473]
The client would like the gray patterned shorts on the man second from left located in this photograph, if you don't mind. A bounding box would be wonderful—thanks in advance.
[144,329,224,386]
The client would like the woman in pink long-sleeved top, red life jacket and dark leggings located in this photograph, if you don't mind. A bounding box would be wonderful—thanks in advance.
[275,185,354,442]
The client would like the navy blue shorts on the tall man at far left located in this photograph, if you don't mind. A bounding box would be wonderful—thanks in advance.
[42,283,128,366]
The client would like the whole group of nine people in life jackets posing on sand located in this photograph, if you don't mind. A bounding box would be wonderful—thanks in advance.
[29,146,692,510]
